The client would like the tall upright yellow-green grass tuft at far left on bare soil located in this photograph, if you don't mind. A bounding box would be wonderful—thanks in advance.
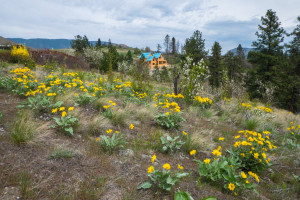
[10,110,36,144]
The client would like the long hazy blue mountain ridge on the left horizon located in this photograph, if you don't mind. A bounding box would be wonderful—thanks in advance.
[7,38,108,49]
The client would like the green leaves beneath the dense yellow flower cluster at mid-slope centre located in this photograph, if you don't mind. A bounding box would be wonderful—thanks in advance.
[154,112,185,129]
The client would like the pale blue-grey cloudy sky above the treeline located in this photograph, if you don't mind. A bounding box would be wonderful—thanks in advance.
[0,0,300,53]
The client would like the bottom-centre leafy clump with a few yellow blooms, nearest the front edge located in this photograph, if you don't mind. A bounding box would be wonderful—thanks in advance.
[137,157,189,192]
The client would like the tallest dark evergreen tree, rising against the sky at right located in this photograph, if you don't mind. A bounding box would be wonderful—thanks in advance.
[246,10,285,101]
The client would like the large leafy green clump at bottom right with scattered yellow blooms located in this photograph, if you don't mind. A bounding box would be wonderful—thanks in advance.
[196,156,259,195]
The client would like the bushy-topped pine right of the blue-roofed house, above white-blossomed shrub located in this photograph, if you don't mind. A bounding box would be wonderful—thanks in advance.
[184,30,207,63]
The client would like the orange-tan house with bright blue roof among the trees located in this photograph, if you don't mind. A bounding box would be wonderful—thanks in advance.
[139,52,168,70]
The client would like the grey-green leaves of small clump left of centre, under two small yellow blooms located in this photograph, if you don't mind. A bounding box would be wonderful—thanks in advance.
[100,133,127,154]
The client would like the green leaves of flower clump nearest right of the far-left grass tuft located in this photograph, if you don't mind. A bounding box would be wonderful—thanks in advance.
[53,115,78,136]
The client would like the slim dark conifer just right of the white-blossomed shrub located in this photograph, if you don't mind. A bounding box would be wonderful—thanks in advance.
[208,42,223,88]
